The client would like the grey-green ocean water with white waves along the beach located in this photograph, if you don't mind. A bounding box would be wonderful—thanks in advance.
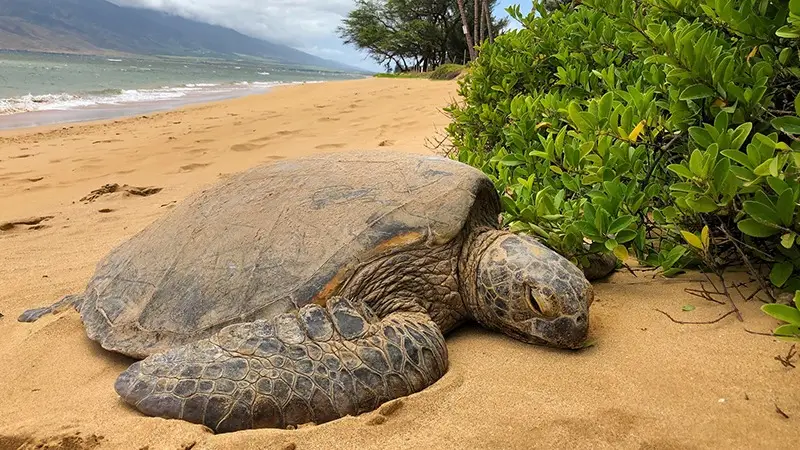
[0,52,364,129]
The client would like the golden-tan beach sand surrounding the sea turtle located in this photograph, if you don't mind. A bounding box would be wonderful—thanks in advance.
[0,79,800,449]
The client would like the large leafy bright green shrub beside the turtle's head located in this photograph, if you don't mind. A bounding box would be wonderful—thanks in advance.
[447,0,800,338]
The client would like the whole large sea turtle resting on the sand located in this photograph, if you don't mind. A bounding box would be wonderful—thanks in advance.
[19,150,614,432]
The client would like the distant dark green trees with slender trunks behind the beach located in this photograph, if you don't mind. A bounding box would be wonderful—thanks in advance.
[337,0,507,72]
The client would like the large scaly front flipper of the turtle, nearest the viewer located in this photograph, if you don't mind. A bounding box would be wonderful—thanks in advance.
[115,297,447,432]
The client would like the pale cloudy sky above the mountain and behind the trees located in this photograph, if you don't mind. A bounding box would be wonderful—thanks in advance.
[111,0,531,70]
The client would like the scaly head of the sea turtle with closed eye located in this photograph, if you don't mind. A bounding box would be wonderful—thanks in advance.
[467,231,594,349]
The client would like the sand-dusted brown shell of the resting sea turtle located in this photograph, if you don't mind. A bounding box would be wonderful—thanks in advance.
[80,151,500,357]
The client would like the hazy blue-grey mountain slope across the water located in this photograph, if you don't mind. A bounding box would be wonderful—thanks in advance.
[0,0,362,72]
